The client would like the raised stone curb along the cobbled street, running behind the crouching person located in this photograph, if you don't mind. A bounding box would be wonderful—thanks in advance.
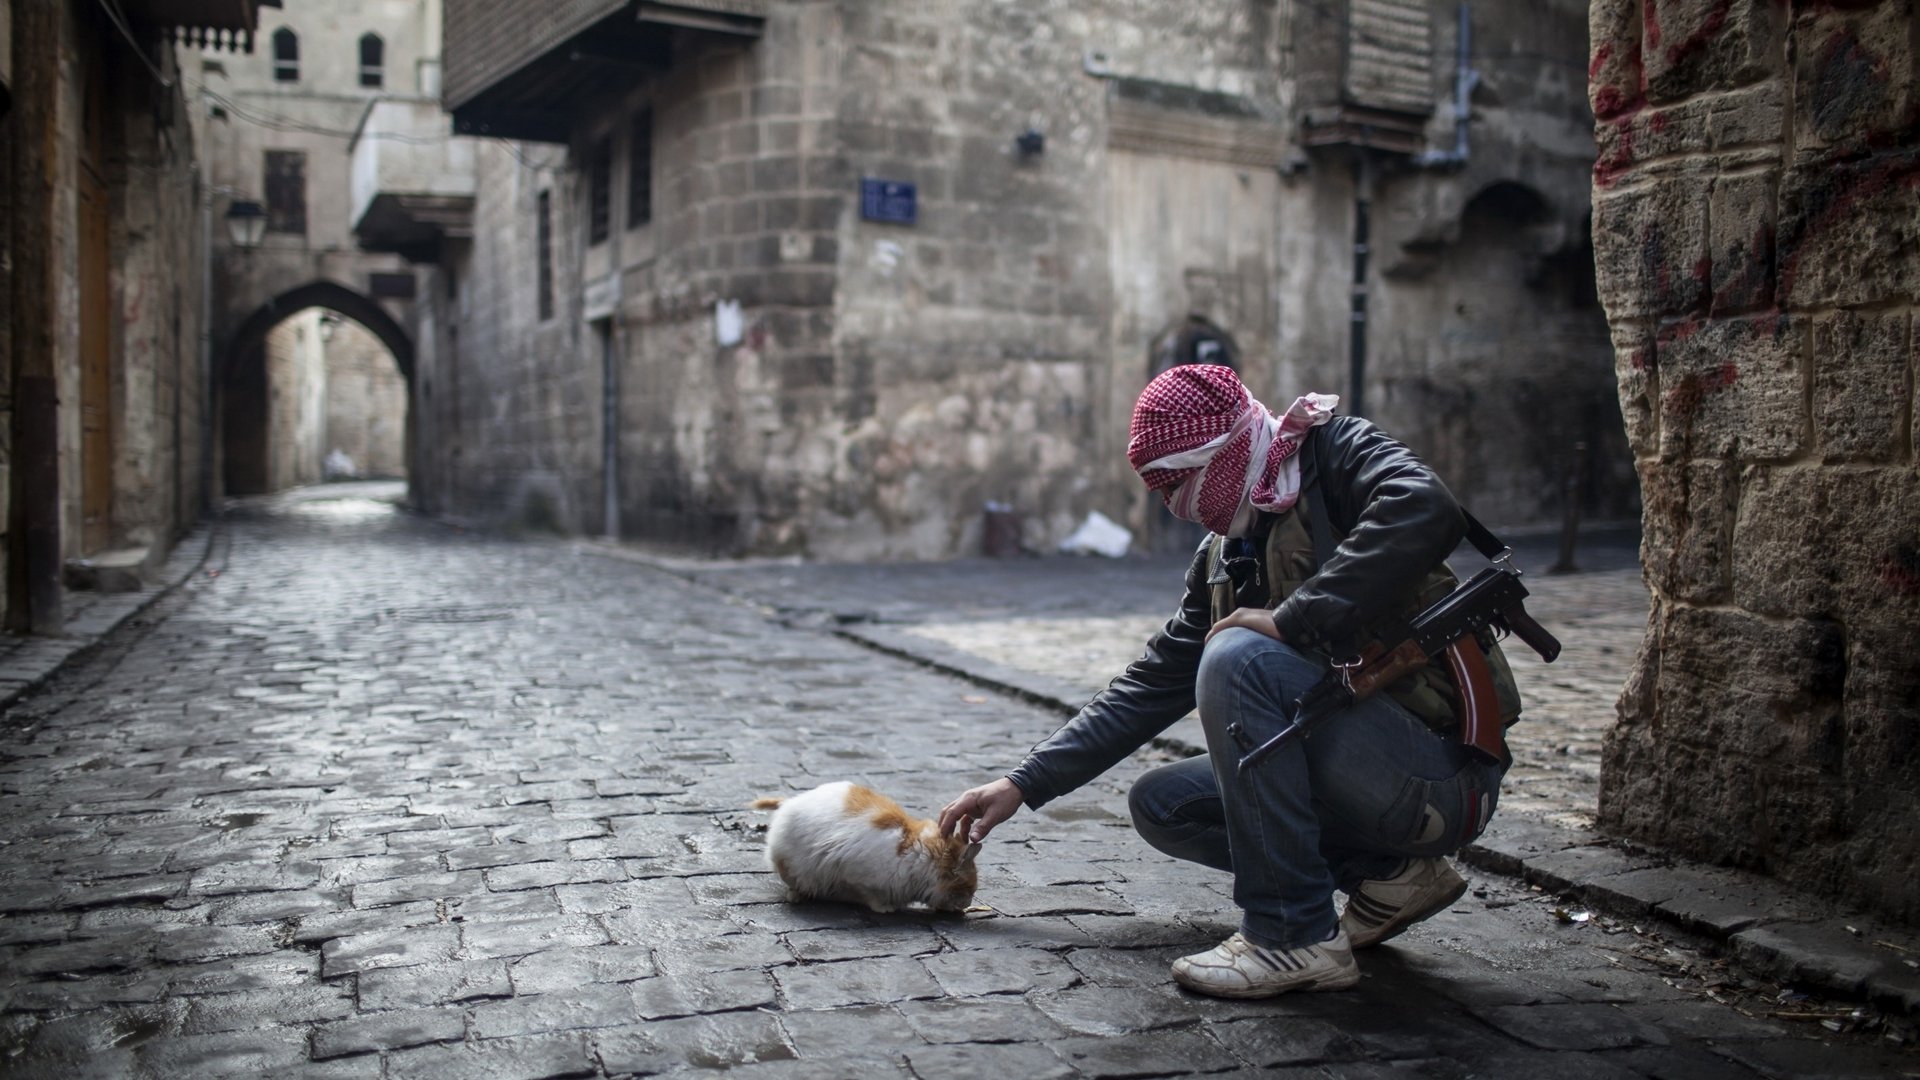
[578,544,1920,1017]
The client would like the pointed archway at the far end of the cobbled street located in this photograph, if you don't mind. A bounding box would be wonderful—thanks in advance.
[215,281,413,494]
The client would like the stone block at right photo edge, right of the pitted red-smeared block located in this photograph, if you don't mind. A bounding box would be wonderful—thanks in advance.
[1812,311,1912,461]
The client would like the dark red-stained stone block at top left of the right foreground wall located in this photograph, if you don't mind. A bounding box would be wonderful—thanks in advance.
[1642,0,1784,102]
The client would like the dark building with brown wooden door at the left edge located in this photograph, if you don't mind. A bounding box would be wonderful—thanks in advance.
[0,0,257,634]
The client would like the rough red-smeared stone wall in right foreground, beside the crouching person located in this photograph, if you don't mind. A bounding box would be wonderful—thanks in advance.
[1590,0,1920,919]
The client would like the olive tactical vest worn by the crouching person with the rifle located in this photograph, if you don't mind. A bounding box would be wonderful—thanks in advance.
[1208,498,1521,736]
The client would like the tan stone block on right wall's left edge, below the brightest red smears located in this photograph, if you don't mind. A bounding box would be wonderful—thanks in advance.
[1594,173,1711,321]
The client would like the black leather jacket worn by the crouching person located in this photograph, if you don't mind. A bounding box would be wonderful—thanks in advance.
[1008,417,1467,807]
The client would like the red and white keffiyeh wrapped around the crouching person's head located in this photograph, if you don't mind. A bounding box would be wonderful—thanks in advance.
[1127,363,1340,536]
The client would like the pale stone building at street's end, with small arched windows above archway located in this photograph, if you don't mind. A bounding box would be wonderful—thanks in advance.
[190,0,432,494]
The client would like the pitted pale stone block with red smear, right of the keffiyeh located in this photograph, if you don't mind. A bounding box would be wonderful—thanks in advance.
[1657,315,1807,461]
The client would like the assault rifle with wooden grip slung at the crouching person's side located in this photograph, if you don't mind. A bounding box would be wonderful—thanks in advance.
[1227,557,1559,773]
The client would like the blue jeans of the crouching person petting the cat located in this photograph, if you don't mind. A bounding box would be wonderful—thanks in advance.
[1127,628,1505,947]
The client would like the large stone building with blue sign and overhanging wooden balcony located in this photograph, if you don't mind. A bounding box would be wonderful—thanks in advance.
[432,0,1638,557]
